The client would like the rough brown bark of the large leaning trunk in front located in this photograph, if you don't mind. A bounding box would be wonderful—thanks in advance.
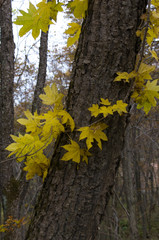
[25,0,146,240]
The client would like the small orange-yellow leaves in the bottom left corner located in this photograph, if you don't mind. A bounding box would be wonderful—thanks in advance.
[0,216,26,232]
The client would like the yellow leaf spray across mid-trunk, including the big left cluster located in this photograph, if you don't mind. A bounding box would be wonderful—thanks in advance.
[6,81,127,175]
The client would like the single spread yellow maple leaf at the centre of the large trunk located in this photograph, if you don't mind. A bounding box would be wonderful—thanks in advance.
[78,123,108,150]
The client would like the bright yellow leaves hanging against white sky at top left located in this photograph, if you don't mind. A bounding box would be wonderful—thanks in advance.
[14,0,63,39]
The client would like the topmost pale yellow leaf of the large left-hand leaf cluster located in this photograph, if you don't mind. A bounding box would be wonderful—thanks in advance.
[39,83,64,109]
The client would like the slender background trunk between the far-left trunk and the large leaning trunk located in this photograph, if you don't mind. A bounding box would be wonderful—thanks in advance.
[32,32,48,113]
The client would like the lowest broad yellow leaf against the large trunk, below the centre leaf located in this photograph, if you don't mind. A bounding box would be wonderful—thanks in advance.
[61,140,81,163]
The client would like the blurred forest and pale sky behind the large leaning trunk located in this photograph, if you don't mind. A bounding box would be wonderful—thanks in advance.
[0,0,159,240]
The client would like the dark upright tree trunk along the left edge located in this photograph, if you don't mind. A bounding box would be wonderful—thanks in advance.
[0,0,14,225]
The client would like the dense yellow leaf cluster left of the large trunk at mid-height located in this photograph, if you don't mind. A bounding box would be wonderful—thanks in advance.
[6,84,75,179]
